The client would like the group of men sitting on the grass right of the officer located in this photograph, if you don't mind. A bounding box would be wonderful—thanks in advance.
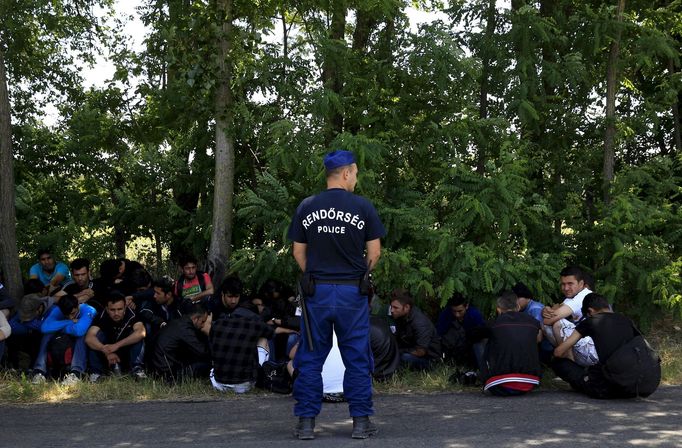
[390,266,661,398]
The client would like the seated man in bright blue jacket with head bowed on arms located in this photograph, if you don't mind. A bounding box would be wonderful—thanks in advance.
[32,295,95,385]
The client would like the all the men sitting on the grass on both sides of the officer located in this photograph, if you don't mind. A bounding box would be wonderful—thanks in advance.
[0,251,660,398]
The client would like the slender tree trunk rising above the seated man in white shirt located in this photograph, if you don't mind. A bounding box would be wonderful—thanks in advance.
[602,0,625,204]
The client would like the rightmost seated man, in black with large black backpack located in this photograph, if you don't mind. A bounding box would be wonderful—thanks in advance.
[552,293,661,398]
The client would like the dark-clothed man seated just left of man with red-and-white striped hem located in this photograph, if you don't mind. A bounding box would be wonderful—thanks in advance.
[436,292,485,369]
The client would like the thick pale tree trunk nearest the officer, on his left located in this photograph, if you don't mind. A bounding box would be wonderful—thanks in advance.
[207,0,235,285]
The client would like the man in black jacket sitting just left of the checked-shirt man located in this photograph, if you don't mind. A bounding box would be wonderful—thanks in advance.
[151,302,210,382]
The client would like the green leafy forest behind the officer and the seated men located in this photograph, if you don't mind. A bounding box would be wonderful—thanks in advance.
[0,0,682,324]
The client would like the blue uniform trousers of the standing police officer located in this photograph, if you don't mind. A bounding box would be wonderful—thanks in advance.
[293,284,374,417]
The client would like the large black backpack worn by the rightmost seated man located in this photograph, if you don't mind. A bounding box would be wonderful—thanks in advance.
[602,333,661,397]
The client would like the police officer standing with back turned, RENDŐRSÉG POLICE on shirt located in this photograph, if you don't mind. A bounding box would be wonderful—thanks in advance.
[289,151,386,440]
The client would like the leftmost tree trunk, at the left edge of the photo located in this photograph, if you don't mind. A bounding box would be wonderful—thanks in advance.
[0,46,23,300]
